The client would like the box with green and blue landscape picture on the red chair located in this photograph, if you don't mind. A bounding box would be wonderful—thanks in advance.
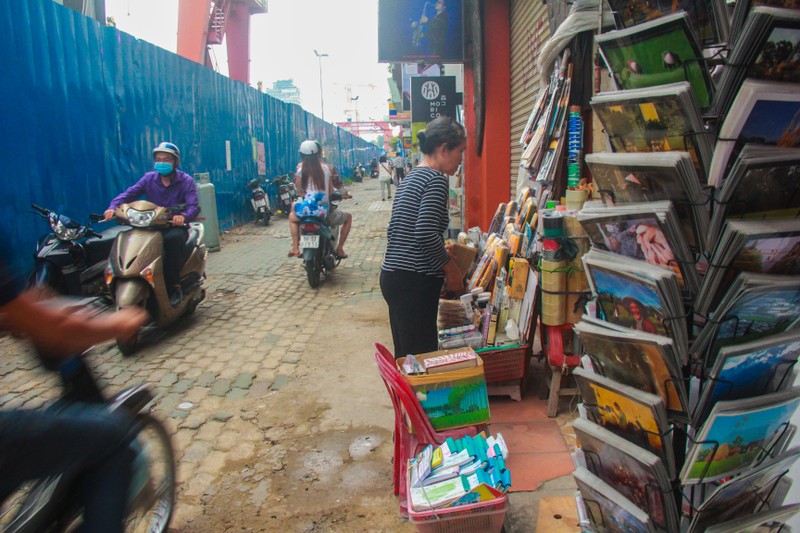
[397,348,489,431]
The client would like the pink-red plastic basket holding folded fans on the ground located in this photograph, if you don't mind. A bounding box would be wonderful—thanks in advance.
[406,476,508,533]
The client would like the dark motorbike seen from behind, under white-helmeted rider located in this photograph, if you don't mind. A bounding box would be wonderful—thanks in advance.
[300,192,342,289]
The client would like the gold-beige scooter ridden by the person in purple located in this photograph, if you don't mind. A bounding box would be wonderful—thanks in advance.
[106,200,207,355]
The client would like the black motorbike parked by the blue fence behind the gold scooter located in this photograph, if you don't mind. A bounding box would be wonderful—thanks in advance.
[28,204,129,298]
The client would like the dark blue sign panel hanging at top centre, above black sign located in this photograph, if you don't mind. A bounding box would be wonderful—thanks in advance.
[378,0,464,63]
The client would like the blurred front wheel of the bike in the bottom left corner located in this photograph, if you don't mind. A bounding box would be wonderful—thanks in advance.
[125,414,175,533]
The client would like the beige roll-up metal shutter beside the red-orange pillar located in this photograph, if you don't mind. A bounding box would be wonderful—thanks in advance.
[506,0,550,200]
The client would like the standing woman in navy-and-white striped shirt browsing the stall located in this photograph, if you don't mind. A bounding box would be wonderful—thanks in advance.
[381,117,467,357]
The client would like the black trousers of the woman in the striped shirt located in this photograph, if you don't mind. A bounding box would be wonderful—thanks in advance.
[381,271,444,358]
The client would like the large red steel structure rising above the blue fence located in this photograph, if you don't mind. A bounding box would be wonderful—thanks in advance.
[178,0,267,84]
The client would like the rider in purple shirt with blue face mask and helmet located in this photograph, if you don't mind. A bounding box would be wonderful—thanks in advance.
[105,142,200,306]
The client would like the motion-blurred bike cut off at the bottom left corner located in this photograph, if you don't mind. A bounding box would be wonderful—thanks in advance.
[0,298,176,533]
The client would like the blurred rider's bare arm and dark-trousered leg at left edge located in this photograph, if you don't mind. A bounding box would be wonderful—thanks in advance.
[0,243,146,533]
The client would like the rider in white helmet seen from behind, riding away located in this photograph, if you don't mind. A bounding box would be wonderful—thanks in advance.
[289,140,353,259]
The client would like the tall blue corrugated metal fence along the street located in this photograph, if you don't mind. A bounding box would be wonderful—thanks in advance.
[0,0,380,274]
